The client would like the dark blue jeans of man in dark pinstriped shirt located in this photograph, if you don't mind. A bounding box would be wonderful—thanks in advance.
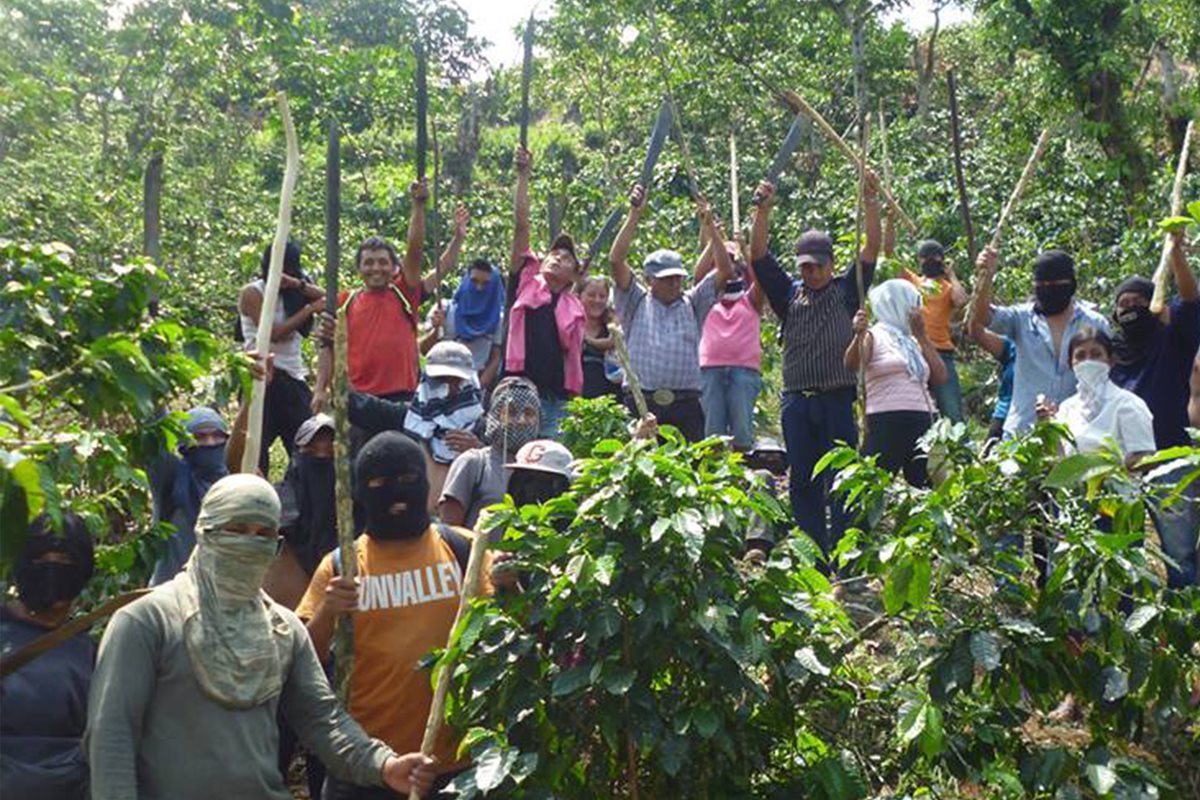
[780,386,858,563]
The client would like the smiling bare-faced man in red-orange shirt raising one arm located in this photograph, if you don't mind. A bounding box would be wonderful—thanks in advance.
[312,179,433,413]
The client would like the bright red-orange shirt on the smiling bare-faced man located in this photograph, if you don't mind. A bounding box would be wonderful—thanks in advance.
[337,277,421,397]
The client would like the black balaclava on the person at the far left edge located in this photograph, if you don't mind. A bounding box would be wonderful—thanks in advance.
[13,513,96,613]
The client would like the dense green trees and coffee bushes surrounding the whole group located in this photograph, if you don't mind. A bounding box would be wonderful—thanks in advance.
[0,0,1200,799]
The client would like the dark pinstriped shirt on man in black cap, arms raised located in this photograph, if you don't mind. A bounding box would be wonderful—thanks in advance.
[754,253,875,392]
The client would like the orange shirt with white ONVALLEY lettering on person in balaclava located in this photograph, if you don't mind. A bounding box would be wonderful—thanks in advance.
[296,525,492,770]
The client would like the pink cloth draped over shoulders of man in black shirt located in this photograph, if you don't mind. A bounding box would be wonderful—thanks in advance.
[504,253,586,395]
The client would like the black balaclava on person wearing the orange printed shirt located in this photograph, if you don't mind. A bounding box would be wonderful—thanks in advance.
[354,431,430,540]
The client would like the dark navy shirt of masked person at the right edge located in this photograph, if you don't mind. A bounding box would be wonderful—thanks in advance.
[1109,297,1200,450]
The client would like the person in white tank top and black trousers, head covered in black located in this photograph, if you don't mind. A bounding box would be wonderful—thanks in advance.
[238,241,325,475]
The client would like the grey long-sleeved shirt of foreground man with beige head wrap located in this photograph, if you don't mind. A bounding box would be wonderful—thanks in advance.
[84,573,392,800]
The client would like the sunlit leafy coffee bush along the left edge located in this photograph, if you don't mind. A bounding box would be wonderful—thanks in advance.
[0,240,220,593]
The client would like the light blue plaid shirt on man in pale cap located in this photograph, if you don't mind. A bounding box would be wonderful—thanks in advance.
[614,273,716,391]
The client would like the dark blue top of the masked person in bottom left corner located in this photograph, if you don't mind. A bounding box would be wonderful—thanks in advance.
[0,608,96,800]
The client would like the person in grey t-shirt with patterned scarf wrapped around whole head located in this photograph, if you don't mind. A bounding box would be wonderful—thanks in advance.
[438,377,541,529]
